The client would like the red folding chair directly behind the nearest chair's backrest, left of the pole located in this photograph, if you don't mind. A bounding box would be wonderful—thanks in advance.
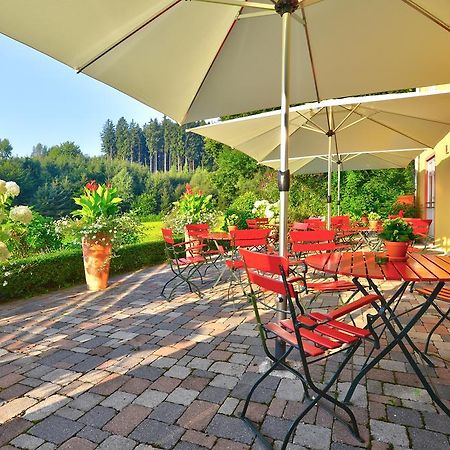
[225,228,272,298]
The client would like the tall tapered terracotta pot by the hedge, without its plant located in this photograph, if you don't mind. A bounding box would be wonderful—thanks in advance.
[82,235,111,291]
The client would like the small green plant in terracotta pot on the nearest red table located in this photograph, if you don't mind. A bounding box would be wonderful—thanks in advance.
[379,218,414,261]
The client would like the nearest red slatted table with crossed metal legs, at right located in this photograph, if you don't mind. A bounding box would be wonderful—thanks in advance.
[306,252,450,417]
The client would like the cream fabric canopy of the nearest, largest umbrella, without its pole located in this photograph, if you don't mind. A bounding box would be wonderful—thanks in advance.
[0,0,450,125]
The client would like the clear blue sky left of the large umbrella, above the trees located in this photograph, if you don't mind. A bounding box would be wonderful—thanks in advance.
[0,34,162,156]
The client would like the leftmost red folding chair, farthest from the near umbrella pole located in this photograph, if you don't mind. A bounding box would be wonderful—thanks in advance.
[161,228,206,300]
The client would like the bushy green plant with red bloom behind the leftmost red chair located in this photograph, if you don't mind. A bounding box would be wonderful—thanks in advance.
[165,184,217,233]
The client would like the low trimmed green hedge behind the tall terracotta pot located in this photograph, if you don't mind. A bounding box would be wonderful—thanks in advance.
[0,241,165,301]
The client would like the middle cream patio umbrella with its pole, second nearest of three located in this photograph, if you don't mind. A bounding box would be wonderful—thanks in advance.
[191,89,450,227]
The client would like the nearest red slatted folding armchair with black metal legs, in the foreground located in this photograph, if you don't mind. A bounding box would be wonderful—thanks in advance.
[240,249,380,450]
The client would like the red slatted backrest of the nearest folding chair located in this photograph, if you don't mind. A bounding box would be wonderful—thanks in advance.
[239,248,295,297]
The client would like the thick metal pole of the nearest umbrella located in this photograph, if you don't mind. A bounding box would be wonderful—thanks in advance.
[275,1,298,358]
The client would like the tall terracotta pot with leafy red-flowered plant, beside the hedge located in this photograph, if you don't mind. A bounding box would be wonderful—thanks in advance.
[72,180,122,291]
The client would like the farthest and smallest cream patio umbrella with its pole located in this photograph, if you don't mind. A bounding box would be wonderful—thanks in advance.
[264,148,424,216]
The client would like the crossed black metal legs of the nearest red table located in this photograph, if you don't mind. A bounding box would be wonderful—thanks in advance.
[344,282,450,417]
